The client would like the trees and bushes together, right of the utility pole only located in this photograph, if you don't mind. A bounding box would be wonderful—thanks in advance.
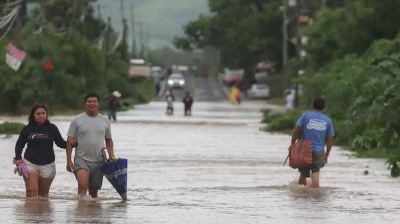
[285,0,400,176]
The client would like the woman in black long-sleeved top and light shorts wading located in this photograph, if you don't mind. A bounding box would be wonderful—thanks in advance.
[13,104,68,198]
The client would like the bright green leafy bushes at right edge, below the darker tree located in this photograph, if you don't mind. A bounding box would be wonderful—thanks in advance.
[299,29,400,176]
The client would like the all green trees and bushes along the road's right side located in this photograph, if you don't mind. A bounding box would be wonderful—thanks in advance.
[175,0,400,176]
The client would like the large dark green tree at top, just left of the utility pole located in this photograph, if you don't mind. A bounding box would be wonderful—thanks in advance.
[174,0,282,70]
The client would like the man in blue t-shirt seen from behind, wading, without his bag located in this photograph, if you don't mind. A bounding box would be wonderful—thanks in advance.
[291,97,334,188]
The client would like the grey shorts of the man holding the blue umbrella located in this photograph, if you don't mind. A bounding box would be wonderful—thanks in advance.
[74,156,104,190]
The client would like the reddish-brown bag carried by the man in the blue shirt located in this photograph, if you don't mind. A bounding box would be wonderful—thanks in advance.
[289,139,312,169]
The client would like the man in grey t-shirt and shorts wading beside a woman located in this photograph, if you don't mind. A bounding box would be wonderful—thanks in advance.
[66,93,115,198]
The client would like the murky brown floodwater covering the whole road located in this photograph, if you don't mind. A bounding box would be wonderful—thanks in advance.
[0,102,400,224]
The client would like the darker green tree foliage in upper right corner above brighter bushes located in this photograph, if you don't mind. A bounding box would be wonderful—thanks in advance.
[303,0,400,68]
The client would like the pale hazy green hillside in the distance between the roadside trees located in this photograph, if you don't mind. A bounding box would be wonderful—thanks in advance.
[95,0,209,49]
